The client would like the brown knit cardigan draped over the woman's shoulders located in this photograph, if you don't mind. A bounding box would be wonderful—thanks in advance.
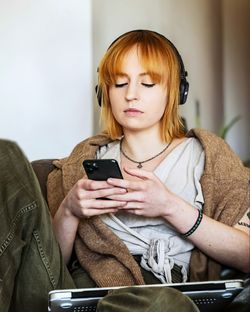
[47,129,250,287]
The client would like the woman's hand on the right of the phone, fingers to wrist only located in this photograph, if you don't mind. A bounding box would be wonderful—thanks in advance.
[107,168,177,217]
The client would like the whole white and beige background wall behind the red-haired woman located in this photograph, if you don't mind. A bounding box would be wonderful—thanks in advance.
[0,0,250,160]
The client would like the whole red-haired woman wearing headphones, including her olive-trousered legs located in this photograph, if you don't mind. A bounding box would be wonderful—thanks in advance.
[0,30,250,311]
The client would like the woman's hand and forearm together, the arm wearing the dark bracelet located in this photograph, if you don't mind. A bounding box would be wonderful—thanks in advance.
[108,169,250,273]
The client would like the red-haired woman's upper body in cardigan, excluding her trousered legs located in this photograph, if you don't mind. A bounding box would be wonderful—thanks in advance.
[48,30,250,285]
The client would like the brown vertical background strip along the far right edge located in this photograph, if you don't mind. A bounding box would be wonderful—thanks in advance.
[223,0,250,160]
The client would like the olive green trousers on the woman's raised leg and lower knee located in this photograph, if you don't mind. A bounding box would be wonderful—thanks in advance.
[0,140,197,312]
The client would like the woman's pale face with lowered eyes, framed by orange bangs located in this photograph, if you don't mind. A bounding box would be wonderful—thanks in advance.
[109,47,167,135]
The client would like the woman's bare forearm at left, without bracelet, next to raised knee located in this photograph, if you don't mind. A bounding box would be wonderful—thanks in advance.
[53,202,79,264]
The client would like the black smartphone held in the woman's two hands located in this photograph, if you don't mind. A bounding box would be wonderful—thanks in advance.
[83,159,123,181]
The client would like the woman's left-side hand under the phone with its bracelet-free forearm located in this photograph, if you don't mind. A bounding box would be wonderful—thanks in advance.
[53,179,126,263]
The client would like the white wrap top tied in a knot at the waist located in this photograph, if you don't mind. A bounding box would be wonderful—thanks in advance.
[97,138,205,283]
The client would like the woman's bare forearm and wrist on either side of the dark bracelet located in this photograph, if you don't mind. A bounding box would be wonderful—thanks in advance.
[165,199,250,272]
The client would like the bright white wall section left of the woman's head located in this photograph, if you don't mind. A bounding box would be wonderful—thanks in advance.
[0,0,92,160]
